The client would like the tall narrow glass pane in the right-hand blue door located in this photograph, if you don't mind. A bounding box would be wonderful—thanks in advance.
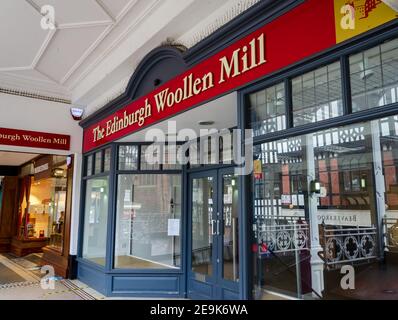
[222,175,239,281]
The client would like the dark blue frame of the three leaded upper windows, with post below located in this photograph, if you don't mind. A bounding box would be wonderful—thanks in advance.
[238,26,398,299]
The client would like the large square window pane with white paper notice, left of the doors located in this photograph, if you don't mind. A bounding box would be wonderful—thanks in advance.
[115,174,181,269]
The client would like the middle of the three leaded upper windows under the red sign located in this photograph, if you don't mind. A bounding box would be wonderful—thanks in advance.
[292,62,343,126]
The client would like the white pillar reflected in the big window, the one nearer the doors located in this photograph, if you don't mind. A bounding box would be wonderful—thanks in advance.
[303,134,324,297]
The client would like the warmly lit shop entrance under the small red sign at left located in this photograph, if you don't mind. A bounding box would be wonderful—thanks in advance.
[0,151,73,278]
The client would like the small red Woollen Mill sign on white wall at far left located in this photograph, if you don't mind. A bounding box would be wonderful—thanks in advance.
[0,128,70,150]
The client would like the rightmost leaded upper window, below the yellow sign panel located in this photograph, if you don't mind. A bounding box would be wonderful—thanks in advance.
[350,39,398,112]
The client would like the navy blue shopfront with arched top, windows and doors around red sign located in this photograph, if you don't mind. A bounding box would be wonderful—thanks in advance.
[76,0,398,300]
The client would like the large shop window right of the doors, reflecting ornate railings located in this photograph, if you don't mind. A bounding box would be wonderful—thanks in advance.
[252,116,398,299]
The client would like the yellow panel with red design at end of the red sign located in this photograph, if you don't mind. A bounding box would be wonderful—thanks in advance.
[334,0,398,43]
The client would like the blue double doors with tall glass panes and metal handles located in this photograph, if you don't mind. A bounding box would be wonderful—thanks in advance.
[188,168,239,299]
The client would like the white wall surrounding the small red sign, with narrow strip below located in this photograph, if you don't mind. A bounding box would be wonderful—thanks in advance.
[0,93,83,254]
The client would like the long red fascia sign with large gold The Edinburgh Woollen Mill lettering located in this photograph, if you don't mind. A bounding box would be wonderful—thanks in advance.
[83,0,336,152]
